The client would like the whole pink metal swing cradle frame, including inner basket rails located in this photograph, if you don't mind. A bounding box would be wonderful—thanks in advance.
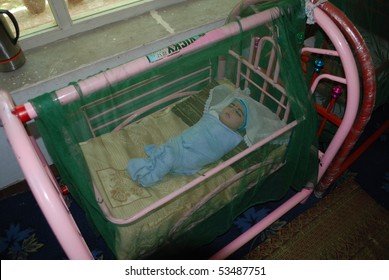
[0,1,374,259]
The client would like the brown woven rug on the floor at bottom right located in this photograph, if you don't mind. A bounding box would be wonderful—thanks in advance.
[245,178,389,260]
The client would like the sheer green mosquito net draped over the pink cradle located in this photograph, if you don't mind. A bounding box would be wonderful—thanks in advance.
[31,0,318,258]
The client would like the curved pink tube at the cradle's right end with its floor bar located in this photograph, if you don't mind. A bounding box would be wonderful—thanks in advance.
[210,1,360,260]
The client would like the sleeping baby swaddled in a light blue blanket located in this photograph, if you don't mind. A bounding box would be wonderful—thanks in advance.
[127,88,248,187]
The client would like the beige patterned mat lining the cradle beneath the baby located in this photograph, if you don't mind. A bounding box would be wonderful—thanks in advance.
[80,80,286,259]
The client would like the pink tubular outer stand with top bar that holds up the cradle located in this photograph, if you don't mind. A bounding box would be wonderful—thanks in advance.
[0,2,366,259]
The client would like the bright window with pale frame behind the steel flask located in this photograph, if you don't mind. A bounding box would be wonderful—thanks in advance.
[0,0,185,50]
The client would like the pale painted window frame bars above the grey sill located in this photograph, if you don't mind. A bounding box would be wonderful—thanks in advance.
[19,0,187,50]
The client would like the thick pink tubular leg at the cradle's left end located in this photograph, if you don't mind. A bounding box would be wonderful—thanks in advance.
[0,91,93,259]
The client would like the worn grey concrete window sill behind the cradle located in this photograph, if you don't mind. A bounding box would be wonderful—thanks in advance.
[0,0,237,104]
